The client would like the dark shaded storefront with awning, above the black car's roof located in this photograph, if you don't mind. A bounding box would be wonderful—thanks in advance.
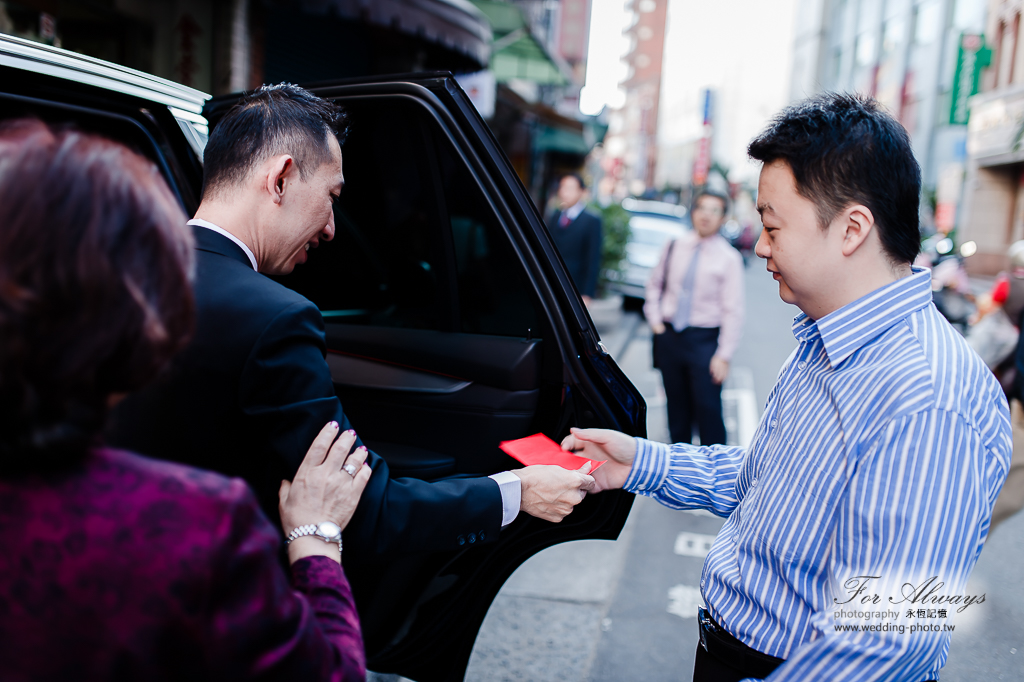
[0,0,492,94]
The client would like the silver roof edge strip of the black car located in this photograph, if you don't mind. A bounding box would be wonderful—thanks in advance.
[0,34,210,127]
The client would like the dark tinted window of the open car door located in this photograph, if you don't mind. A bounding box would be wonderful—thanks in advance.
[281,97,538,337]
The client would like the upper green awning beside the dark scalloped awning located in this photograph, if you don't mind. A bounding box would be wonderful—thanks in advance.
[473,0,569,85]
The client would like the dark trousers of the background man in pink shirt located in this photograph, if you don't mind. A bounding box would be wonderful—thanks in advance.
[657,326,725,445]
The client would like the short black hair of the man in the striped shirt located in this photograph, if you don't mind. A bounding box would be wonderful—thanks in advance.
[746,92,921,263]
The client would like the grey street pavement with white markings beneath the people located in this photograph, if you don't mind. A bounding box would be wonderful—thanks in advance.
[370,260,1024,682]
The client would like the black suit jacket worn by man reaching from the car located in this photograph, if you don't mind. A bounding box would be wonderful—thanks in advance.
[110,226,502,567]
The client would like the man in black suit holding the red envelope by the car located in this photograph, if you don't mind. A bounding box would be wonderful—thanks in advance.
[111,85,593,566]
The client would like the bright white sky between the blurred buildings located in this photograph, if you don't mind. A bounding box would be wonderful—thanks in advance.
[580,0,797,180]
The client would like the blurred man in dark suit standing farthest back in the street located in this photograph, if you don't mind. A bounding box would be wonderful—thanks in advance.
[548,173,602,305]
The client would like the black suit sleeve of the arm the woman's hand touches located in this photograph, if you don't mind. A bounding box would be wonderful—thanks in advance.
[239,302,502,555]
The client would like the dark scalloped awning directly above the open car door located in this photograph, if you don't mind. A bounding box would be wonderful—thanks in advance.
[301,0,492,69]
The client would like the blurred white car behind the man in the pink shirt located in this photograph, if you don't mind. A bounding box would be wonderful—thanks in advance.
[614,199,690,306]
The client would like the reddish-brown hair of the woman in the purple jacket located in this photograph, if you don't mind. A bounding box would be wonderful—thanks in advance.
[0,120,194,473]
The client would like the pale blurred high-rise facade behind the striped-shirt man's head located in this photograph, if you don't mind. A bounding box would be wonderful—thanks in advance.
[790,0,986,241]
